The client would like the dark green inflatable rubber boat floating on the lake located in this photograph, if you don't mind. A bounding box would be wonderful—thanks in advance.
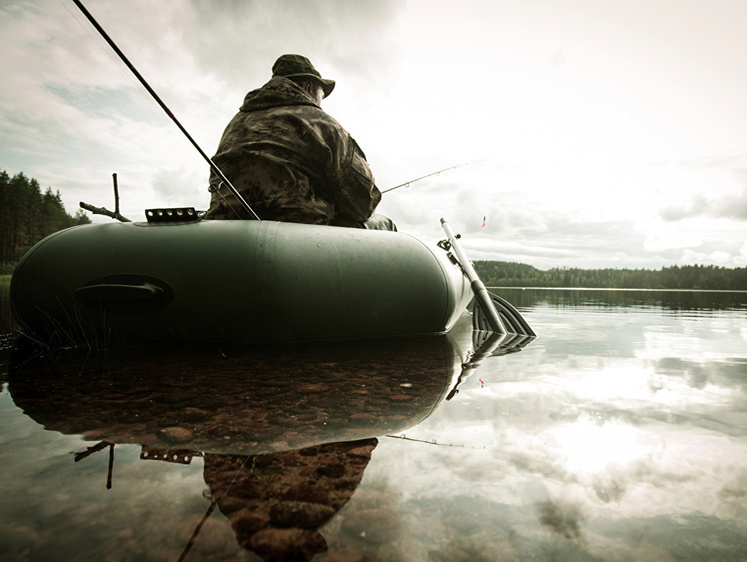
[11,221,480,348]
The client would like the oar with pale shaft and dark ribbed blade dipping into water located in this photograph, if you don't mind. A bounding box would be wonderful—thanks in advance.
[441,218,536,337]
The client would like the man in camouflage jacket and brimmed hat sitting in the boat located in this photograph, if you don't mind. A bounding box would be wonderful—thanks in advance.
[206,55,396,230]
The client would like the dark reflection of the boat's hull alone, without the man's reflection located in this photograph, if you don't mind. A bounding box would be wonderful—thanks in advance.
[10,337,462,455]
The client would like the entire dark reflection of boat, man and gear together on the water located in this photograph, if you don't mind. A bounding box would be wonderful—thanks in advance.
[9,312,530,560]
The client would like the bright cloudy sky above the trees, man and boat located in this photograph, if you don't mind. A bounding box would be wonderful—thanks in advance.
[0,0,747,269]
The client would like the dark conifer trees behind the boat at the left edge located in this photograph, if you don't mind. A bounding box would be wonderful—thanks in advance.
[0,170,91,273]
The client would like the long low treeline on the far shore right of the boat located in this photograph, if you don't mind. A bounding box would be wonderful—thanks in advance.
[474,261,747,291]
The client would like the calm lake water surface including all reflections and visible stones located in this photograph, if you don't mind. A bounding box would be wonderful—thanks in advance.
[0,289,747,561]
